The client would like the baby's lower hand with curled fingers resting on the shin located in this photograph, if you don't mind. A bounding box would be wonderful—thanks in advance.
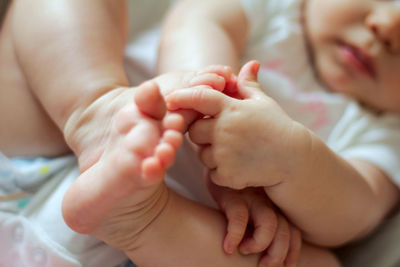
[208,179,301,266]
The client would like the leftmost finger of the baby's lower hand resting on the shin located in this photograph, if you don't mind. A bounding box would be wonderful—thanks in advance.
[221,199,249,254]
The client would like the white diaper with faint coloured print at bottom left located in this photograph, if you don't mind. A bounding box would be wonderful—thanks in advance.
[0,154,126,267]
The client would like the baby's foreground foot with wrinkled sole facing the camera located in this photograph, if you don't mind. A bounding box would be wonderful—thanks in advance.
[63,82,183,251]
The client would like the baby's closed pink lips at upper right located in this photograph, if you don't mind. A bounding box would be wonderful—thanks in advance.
[339,43,377,79]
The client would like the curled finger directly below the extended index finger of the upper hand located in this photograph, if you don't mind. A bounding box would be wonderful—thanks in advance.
[189,118,216,145]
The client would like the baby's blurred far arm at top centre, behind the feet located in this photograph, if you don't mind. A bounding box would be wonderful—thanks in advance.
[158,0,247,73]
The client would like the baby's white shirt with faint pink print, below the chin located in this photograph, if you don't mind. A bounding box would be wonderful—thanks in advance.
[241,0,400,186]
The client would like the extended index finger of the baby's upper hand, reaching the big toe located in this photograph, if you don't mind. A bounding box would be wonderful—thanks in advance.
[166,86,230,116]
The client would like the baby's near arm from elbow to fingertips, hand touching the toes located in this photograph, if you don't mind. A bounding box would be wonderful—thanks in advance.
[167,62,399,249]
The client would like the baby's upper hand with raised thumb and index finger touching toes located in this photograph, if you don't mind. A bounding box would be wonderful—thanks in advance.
[167,62,311,189]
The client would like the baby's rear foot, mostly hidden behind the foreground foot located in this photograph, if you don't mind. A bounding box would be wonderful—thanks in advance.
[63,65,235,171]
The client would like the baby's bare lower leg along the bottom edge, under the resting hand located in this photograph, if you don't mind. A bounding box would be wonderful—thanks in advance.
[119,177,340,267]
